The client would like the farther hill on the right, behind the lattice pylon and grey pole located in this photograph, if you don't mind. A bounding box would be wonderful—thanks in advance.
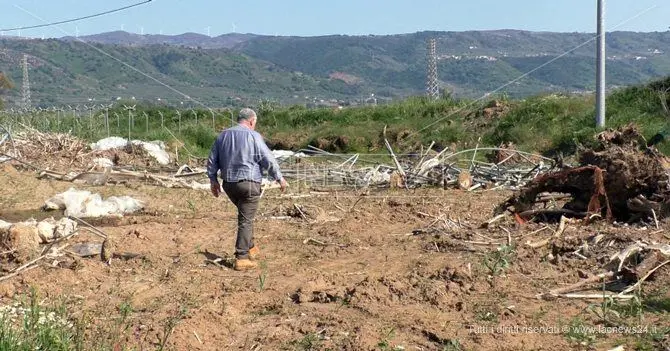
[235,30,670,96]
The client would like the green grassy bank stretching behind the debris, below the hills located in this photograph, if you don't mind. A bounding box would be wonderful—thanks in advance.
[0,78,670,161]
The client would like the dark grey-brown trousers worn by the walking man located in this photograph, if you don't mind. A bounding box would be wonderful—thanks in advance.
[223,181,261,258]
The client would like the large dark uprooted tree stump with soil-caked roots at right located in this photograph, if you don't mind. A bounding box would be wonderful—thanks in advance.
[496,126,670,221]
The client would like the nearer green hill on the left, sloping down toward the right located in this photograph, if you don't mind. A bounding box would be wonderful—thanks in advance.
[0,40,346,106]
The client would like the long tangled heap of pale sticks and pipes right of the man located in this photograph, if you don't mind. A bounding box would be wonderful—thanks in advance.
[282,141,553,191]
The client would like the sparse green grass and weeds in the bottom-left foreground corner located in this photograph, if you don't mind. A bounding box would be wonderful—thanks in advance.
[0,289,189,351]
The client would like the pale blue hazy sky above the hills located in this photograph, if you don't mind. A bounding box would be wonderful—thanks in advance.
[0,0,670,37]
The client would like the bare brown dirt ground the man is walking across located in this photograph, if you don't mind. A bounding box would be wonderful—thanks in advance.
[0,166,670,350]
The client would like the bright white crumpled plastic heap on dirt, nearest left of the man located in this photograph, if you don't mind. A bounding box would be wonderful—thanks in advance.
[44,188,144,218]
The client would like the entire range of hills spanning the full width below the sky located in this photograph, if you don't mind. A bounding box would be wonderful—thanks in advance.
[0,30,670,106]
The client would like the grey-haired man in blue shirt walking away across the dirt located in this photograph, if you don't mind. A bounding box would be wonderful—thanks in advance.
[207,108,286,270]
